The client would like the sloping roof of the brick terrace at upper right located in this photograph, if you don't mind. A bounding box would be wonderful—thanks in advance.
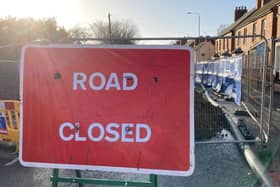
[219,0,280,36]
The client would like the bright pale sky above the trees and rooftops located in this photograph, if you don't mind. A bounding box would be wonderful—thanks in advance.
[0,0,256,37]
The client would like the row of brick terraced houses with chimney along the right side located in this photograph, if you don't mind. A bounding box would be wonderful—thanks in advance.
[215,0,280,109]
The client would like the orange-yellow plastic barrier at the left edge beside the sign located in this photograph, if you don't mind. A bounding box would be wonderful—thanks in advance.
[0,100,19,151]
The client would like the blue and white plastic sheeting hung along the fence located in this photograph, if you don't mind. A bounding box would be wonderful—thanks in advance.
[196,55,242,105]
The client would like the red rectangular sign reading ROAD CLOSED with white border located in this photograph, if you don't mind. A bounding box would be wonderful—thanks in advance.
[20,45,194,176]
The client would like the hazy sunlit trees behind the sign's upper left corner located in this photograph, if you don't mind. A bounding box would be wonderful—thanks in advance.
[0,16,70,60]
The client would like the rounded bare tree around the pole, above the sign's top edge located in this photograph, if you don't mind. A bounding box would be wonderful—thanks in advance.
[89,20,138,44]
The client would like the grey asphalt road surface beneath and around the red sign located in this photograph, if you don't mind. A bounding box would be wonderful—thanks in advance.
[0,140,256,187]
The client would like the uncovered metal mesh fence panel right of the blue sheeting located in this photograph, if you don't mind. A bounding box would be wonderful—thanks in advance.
[242,42,272,141]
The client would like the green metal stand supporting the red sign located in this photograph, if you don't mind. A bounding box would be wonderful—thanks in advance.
[51,169,157,187]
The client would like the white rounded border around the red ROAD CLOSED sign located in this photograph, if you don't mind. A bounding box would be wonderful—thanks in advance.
[19,44,195,176]
